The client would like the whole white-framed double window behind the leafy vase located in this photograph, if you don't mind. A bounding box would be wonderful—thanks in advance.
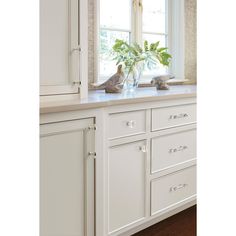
[96,0,184,83]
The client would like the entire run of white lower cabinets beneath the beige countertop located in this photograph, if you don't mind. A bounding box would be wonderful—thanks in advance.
[40,95,196,236]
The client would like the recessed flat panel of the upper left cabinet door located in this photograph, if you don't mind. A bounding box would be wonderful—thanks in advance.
[40,0,70,85]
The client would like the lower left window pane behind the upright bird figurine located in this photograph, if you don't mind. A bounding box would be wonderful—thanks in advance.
[99,30,130,80]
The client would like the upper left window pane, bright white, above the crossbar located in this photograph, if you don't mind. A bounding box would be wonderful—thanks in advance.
[100,0,131,30]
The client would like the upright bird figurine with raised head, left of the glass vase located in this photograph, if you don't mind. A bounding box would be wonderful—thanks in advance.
[93,65,124,93]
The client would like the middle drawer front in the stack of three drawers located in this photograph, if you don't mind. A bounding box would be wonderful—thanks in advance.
[151,129,196,173]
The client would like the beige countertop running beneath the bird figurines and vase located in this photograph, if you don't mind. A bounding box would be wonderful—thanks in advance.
[40,85,197,114]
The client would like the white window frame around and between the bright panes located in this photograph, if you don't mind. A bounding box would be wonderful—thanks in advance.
[94,0,186,84]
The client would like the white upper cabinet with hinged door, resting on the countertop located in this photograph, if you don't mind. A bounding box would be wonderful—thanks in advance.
[40,0,88,97]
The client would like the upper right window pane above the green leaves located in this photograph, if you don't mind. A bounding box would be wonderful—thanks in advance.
[143,0,166,33]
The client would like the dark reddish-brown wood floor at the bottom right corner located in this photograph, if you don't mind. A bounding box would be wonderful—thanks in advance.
[133,206,197,236]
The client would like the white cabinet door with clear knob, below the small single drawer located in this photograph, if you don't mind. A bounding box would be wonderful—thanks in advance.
[108,141,146,233]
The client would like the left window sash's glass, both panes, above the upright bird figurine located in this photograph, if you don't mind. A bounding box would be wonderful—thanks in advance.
[99,0,131,79]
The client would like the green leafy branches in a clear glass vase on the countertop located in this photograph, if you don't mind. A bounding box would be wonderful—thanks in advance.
[112,39,172,90]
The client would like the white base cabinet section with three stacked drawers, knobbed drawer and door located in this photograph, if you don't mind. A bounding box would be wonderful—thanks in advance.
[104,100,196,236]
